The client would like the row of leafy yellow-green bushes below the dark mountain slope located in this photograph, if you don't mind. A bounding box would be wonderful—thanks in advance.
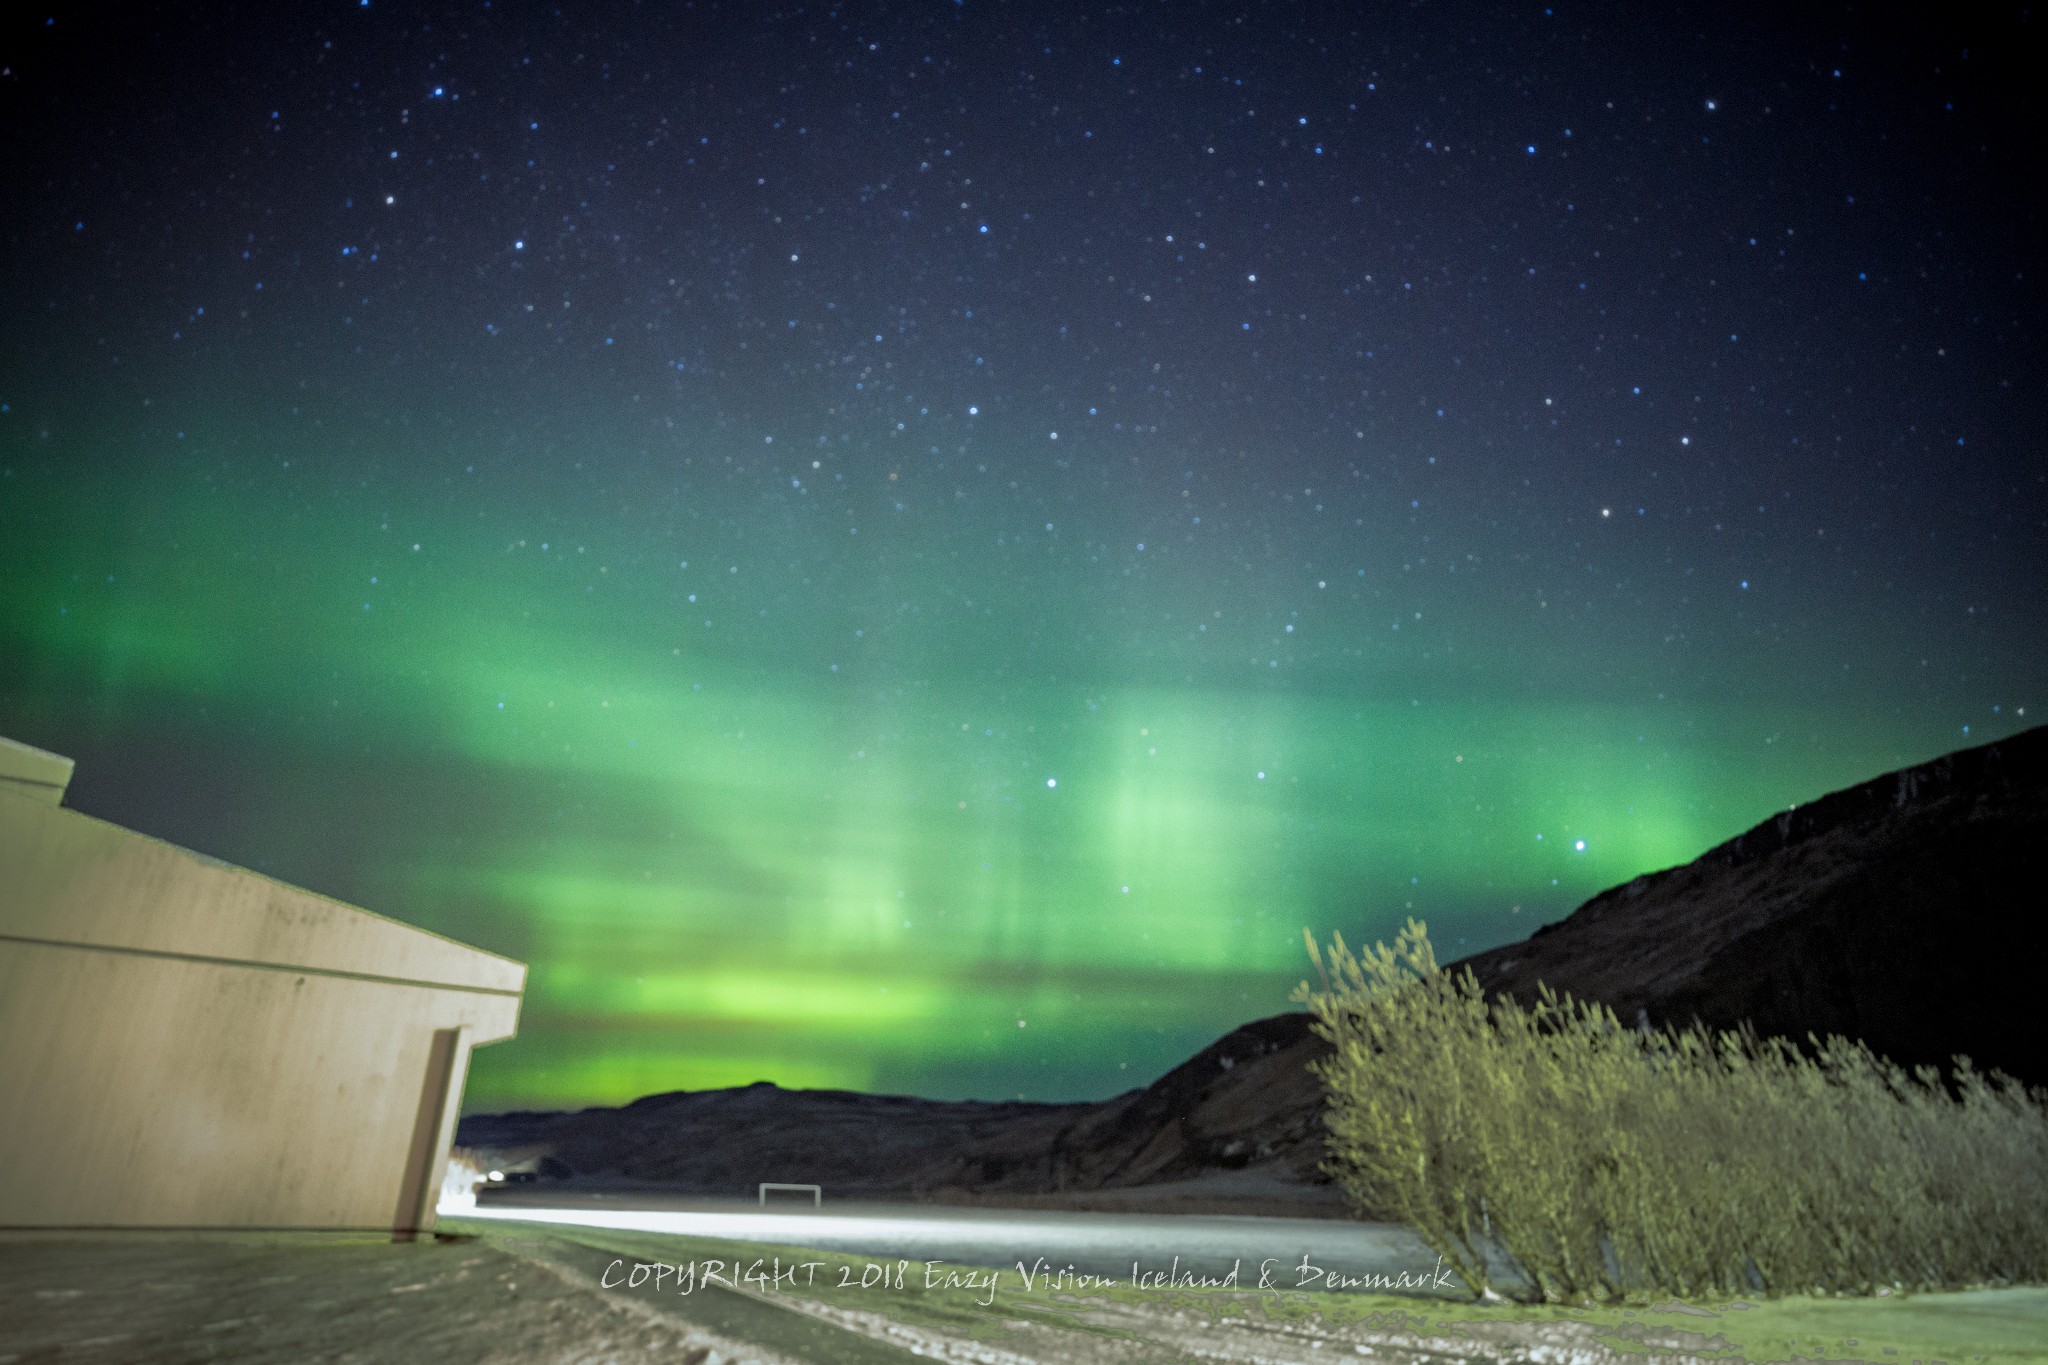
[1296,919,2048,1302]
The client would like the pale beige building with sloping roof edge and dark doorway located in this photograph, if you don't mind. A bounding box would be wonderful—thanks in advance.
[0,739,526,1236]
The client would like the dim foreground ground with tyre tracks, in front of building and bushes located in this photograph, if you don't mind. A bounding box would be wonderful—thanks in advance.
[0,1220,2048,1365]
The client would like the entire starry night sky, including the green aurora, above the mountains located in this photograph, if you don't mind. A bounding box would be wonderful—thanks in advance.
[0,0,2048,1111]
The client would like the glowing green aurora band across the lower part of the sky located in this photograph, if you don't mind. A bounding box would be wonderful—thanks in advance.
[0,419,2015,1109]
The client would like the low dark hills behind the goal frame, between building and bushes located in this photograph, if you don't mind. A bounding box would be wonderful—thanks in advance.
[457,1015,1341,1216]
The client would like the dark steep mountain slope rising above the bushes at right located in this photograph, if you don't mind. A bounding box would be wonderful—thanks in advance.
[1458,729,2048,1085]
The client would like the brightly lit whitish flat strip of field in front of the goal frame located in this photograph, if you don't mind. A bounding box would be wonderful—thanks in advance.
[460,1195,1511,1297]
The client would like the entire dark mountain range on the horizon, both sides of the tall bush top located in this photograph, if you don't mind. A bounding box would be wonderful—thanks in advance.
[459,726,2048,1216]
